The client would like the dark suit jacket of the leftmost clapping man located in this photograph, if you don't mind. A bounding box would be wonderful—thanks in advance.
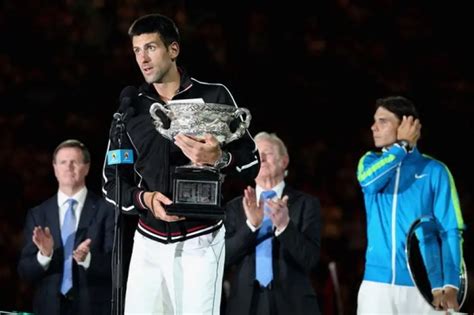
[18,191,114,315]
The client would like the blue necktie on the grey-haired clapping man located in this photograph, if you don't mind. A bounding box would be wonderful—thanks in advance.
[255,190,276,287]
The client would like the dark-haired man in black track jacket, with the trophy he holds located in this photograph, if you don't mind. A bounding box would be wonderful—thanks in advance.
[103,14,260,314]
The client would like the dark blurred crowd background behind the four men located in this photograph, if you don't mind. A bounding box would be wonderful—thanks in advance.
[0,0,474,315]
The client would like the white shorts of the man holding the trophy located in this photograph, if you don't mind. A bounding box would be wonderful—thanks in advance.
[125,227,225,315]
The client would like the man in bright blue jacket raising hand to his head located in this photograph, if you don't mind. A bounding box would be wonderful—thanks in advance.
[357,96,464,314]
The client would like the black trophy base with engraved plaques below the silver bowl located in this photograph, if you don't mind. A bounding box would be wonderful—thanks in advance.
[165,166,225,219]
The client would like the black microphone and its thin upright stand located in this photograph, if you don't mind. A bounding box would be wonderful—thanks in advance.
[112,116,125,315]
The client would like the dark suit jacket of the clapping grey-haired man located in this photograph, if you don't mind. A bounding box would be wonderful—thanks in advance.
[225,186,321,315]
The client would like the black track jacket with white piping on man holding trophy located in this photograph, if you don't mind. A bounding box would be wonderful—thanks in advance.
[103,72,260,243]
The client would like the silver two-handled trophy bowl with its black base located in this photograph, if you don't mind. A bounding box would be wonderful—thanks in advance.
[150,100,252,219]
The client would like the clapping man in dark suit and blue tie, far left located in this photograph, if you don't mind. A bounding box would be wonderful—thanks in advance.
[18,140,114,315]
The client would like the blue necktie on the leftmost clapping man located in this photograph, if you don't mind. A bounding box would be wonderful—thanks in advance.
[61,199,77,295]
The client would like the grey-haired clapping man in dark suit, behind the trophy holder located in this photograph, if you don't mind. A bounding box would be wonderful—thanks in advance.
[225,132,321,315]
